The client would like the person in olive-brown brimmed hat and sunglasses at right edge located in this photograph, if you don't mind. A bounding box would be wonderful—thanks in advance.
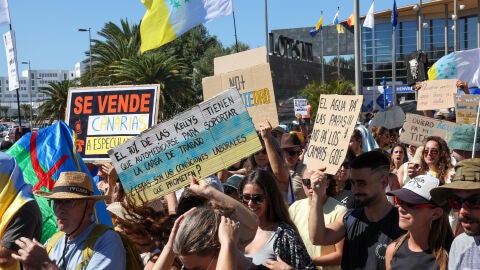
[430,158,480,270]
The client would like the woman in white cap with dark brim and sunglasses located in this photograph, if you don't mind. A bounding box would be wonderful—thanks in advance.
[385,175,453,270]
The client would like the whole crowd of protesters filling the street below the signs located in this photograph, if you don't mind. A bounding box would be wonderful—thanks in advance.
[0,103,480,270]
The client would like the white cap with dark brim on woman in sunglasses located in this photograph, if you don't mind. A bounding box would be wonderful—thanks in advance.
[387,175,440,204]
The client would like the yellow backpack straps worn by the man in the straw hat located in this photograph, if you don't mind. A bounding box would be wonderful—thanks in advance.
[45,224,143,270]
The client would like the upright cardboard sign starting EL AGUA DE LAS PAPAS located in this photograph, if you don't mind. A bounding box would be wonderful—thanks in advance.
[306,95,363,174]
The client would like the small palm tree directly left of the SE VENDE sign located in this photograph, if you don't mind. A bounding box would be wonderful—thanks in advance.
[35,80,78,125]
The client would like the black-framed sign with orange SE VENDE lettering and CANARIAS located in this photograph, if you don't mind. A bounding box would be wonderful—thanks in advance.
[65,85,159,161]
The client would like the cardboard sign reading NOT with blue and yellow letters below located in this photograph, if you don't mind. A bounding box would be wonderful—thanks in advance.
[202,63,278,129]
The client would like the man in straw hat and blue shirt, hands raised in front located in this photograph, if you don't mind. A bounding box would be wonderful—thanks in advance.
[12,172,126,270]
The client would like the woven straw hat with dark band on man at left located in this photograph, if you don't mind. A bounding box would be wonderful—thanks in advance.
[34,172,110,201]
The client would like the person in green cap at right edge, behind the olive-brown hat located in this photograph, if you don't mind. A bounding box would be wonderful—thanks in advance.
[448,125,480,165]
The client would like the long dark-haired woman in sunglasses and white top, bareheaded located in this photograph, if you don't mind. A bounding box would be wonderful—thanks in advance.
[239,169,315,269]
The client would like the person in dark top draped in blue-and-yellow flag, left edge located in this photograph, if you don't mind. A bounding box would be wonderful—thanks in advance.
[0,152,42,270]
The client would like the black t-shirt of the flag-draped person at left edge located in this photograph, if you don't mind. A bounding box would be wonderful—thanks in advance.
[2,200,42,252]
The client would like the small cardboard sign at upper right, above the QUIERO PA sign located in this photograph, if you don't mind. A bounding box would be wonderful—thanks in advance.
[417,79,457,111]
